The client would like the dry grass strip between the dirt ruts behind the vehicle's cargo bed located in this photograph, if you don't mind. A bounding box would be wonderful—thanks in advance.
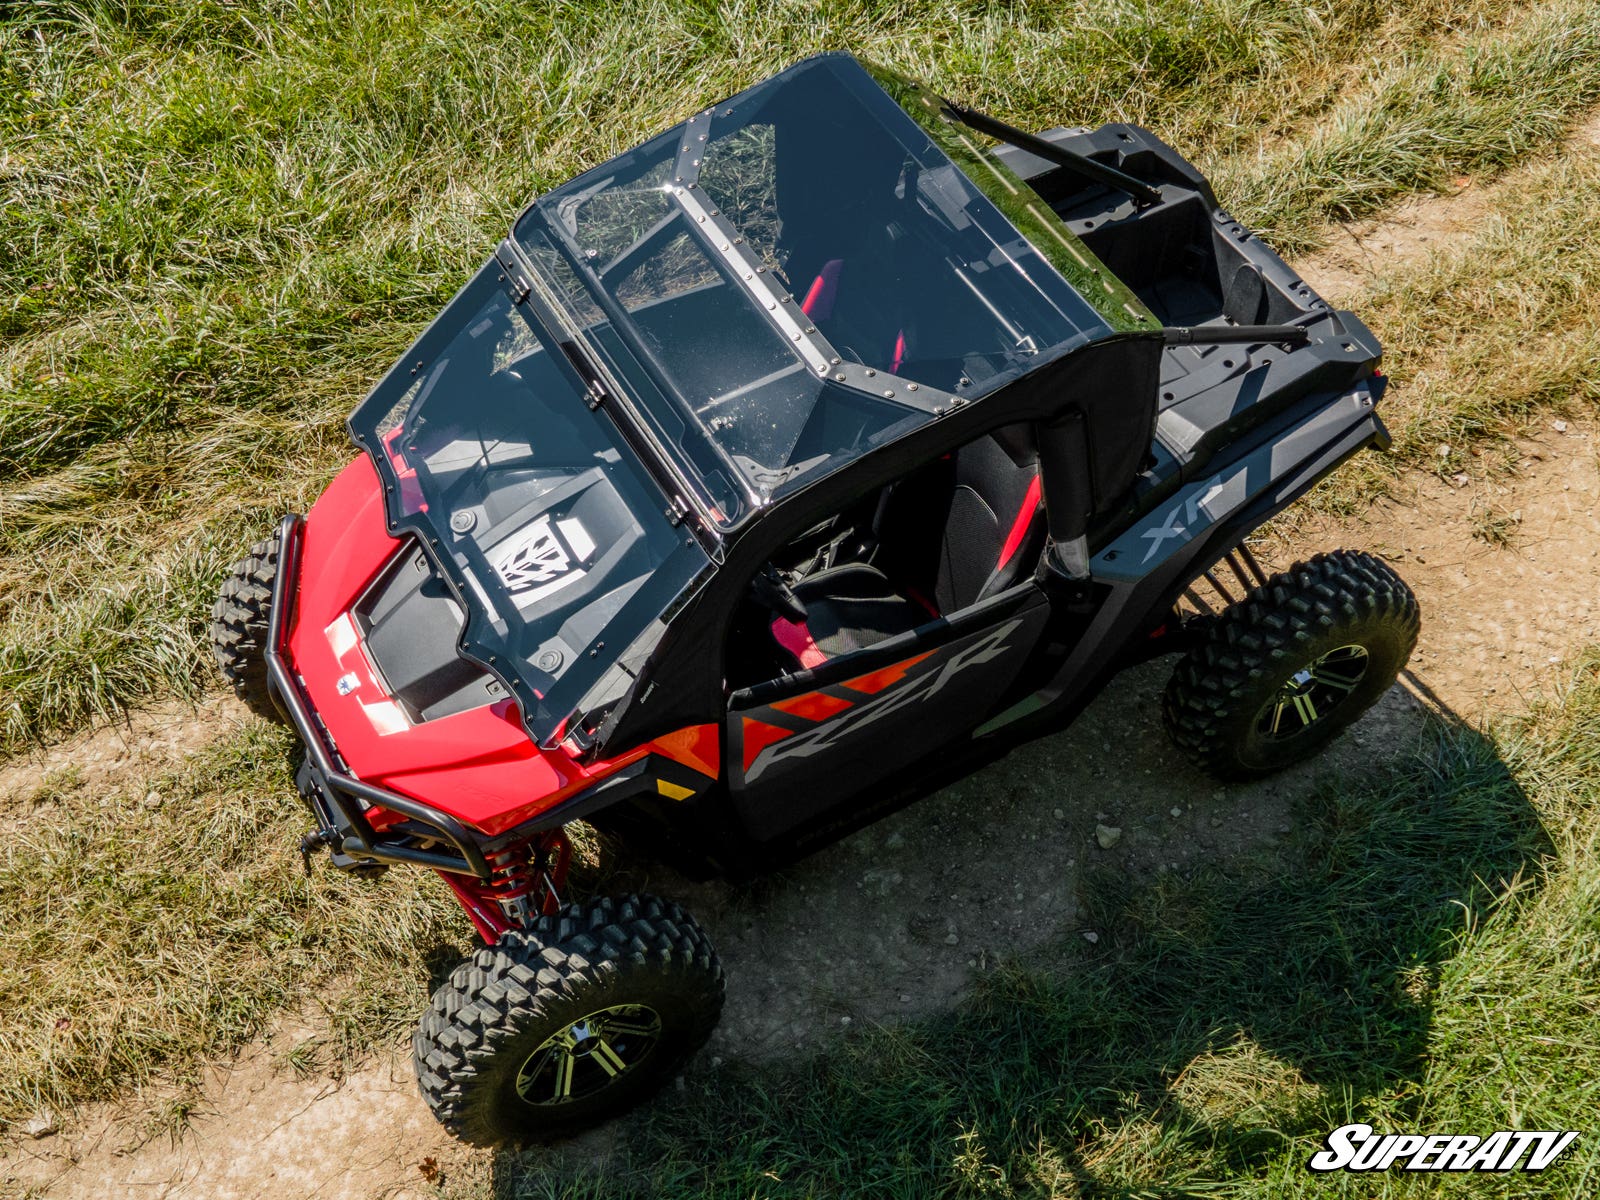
[1283,146,1600,521]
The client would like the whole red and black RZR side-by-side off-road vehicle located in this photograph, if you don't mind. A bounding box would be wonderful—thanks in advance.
[214,54,1418,1142]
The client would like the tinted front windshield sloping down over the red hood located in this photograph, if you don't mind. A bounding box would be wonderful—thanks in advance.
[350,262,709,742]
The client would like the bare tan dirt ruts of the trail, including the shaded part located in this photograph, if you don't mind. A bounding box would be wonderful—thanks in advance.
[0,136,1600,1200]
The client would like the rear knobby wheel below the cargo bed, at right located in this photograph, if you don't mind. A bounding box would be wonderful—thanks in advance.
[1162,550,1421,779]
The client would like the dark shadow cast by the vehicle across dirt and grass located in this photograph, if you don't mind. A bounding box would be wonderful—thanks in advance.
[496,678,1550,1195]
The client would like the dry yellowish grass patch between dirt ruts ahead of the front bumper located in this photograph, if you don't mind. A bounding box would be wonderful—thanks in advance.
[0,723,470,1120]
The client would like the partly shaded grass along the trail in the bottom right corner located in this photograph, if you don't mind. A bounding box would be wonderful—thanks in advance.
[483,654,1600,1197]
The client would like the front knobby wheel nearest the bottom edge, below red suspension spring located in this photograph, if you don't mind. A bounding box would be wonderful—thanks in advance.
[413,894,723,1146]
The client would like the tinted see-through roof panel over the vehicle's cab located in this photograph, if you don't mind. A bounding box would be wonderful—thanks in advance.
[515,54,1114,525]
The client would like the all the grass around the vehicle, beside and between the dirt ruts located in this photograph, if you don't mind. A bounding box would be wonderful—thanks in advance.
[0,0,1600,1197]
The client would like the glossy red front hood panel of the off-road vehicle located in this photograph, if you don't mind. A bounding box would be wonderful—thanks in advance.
[288,454,645,835]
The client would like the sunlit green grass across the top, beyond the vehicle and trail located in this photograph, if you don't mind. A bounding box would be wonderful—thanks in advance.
[0,0,1600,754]
